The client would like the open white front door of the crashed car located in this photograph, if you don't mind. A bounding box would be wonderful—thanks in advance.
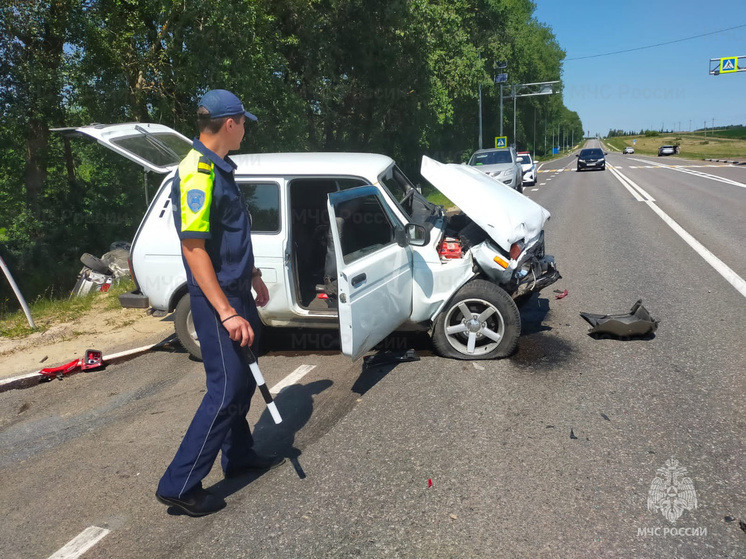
[328,186,412,359]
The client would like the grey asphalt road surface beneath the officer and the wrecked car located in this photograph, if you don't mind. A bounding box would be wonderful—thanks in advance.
[0,145,746,558]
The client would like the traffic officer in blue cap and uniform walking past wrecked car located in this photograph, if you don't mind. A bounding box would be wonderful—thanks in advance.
[156,89,285,516]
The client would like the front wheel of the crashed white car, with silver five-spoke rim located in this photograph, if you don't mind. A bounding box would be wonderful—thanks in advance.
[432,279,521,360]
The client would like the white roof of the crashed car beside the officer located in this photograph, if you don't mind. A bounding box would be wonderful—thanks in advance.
[229,152,394,178]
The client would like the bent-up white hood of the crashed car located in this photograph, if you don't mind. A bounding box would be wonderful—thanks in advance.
[420,156,550,252]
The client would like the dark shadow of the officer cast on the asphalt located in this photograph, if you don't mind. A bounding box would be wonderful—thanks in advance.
[205,379,334,498]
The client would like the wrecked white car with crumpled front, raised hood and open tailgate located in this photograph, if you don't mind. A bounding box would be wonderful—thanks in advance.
[65,123,560,359]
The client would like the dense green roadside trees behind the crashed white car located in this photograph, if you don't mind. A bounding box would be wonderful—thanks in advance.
[0,0,582,310]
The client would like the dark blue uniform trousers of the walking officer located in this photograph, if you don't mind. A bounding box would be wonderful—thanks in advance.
[158,293,261,497]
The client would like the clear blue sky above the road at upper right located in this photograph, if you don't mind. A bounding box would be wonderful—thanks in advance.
[534,0,746,136]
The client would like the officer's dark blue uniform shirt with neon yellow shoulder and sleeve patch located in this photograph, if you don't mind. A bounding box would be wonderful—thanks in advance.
[171,138,254,295]
